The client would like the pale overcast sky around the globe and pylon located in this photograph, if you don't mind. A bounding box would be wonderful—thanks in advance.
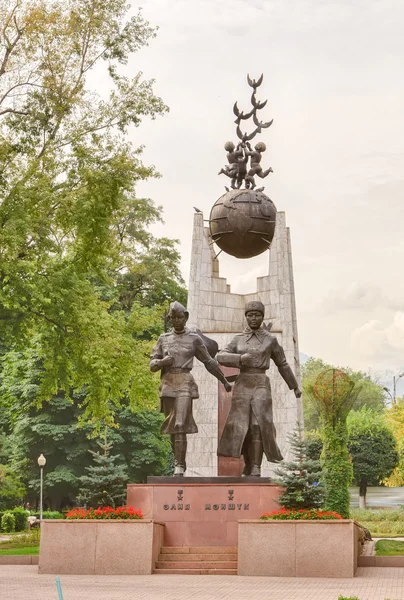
[123,0,404,393]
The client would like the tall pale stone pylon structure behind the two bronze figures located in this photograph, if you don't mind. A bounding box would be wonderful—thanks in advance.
[186,212,303,477]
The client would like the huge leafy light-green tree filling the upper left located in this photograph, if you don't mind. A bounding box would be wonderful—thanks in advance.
[0,0,177,423]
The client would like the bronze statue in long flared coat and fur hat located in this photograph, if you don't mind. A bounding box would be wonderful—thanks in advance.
[217,302,302,477]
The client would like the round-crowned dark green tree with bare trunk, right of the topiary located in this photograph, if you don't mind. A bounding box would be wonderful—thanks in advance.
[347,406,398,508]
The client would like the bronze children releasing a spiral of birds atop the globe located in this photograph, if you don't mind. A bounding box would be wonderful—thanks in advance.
[219,75,273,191]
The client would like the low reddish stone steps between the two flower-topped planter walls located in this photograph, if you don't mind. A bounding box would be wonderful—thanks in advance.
[153,546,237,575]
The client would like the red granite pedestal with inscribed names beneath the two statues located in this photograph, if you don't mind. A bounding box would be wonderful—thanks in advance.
[127,477,281,547]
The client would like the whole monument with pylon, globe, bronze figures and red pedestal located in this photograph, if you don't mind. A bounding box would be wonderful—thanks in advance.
[127,76,302,547]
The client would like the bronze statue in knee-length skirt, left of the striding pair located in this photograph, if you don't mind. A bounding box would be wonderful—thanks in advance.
[150,302,231,476]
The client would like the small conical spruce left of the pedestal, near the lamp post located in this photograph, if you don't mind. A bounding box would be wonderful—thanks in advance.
[77,428,128,508]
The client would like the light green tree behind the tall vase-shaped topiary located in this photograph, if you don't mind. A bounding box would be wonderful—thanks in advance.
[302,358,385,431]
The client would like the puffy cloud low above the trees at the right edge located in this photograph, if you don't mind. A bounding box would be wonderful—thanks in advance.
[351,311,404,366]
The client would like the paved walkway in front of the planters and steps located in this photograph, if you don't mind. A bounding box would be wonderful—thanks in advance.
[0,566,404,600]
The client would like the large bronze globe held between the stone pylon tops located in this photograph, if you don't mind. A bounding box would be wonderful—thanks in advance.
[209,189,276,258]
